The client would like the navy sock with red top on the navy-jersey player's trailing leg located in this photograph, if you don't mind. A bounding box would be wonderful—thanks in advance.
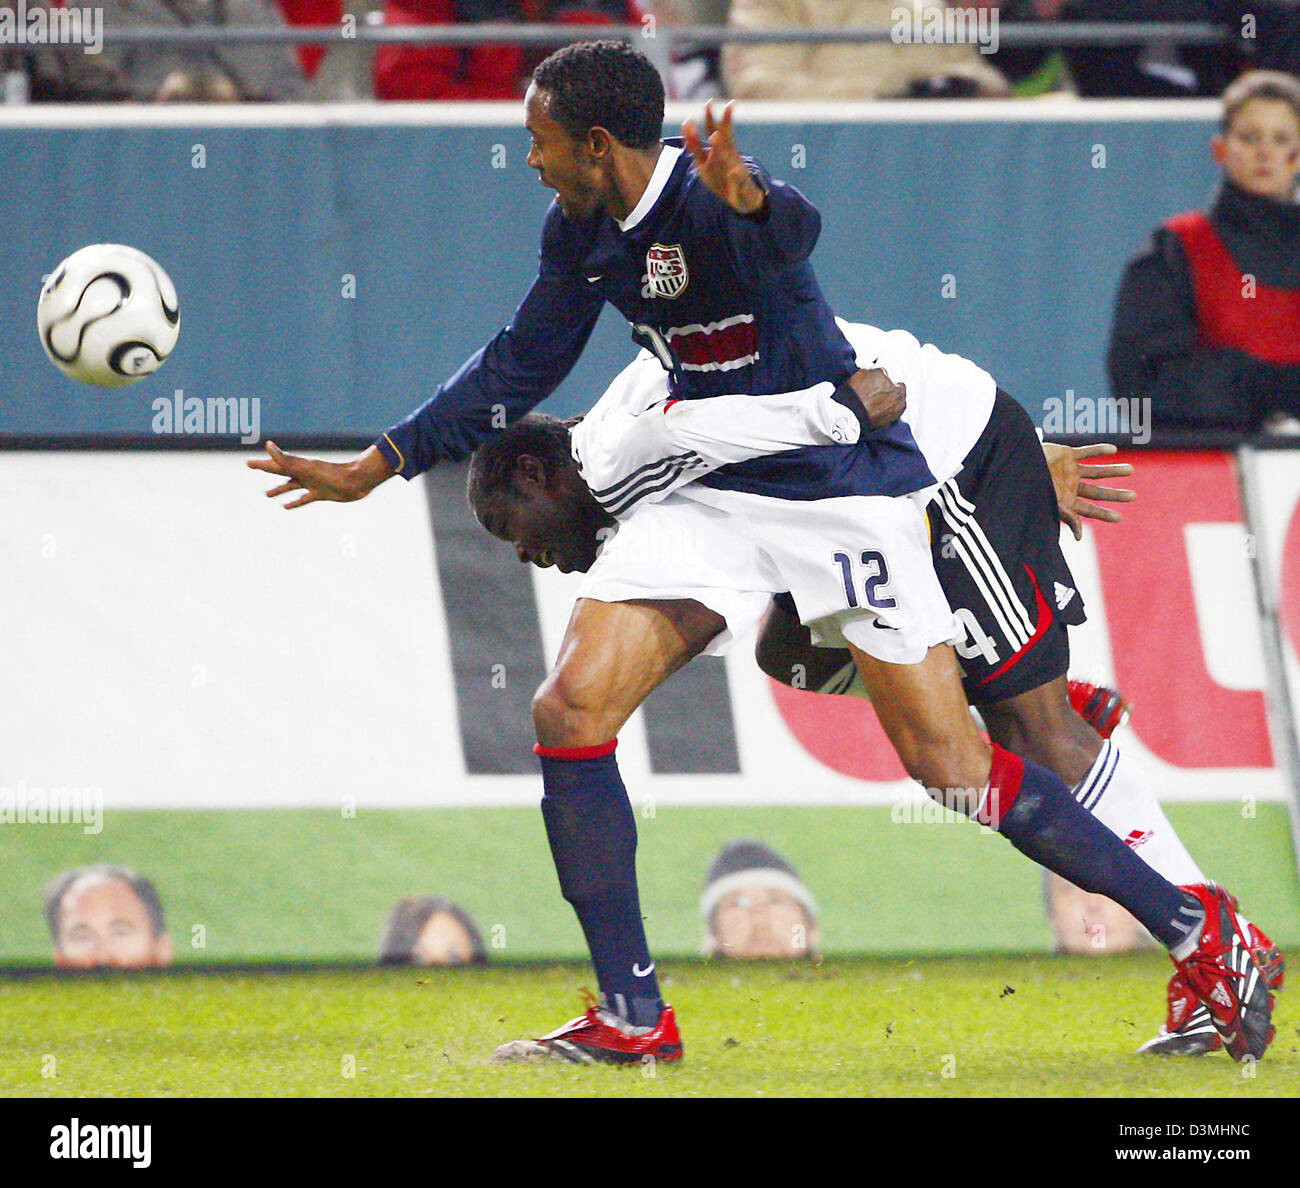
[975,743,1204,949]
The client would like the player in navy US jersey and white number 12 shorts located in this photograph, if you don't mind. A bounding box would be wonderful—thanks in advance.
[250,42,1271,1062]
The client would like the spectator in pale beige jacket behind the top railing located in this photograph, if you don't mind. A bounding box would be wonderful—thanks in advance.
[723,0,1009,99]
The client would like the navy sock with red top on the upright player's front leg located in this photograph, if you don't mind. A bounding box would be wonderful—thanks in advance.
[534,742,663,1027]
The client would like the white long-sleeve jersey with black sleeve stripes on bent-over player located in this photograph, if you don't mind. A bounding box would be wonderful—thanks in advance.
[572,321,997,517]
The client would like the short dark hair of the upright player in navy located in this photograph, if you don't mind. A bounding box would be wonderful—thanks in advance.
[533,40,664,148]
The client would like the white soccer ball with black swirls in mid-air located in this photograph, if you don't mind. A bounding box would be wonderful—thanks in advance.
[36,243,181,387]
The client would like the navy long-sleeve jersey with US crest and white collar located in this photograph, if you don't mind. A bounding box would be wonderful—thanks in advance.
[376,139,935,499]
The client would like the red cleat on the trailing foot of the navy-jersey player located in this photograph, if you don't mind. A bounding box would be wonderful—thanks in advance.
[1170,883,1273,1061]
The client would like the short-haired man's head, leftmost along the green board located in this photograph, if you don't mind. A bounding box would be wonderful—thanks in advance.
[44,863,172,970]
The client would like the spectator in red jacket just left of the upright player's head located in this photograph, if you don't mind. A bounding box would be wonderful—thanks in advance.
[374,0,641,100]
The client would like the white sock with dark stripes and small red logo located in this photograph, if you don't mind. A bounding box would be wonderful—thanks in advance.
[1074,738,1208,886]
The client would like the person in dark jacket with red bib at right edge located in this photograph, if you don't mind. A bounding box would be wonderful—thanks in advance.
[1109,71,1300,432]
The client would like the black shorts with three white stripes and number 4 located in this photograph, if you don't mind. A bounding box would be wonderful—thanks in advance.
[926,389,1086,706]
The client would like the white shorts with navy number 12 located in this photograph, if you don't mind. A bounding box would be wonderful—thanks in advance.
[577,485,962,664]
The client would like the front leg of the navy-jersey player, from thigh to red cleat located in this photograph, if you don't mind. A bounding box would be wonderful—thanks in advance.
[497,599,725,1063]
